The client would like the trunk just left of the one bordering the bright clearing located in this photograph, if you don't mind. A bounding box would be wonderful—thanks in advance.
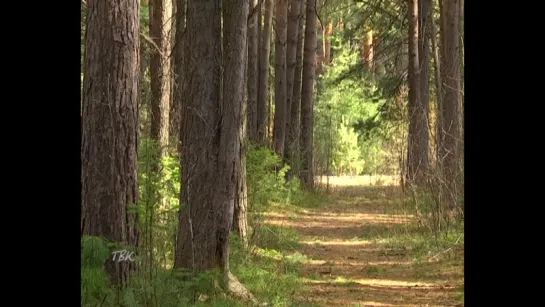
[285,0,304,174]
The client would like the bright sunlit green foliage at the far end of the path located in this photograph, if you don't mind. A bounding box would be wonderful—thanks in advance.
[314,37,398,175]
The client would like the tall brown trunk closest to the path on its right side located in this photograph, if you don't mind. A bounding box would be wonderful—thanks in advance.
[406,0,428,185]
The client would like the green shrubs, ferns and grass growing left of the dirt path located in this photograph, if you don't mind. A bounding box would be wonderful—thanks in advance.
[81,139,324,307]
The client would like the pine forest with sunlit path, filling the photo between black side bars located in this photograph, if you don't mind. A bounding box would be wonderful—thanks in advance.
[80,0,464,307]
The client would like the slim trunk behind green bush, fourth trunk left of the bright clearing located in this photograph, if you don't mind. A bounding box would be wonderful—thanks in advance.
[257,0,274,146]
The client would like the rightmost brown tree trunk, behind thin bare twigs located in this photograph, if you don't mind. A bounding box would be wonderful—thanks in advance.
[440,0,461,208]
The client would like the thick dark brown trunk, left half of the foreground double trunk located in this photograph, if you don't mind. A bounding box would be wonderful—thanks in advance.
[174,0,224,273]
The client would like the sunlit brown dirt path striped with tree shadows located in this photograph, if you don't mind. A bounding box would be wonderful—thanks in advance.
[264,177,464,306]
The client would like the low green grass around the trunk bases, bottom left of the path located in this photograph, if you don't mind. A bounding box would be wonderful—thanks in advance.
[81,230,307,307]
